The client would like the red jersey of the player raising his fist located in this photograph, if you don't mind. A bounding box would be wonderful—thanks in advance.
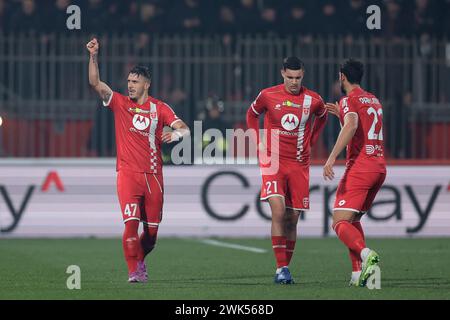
[104,92,180,174]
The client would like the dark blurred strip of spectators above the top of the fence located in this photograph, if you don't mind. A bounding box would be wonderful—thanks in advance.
[0,0,450,37]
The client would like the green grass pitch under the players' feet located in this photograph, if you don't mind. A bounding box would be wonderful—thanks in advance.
[0,238,450,300]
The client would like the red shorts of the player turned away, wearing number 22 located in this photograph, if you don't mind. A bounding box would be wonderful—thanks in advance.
[333,170,386,212]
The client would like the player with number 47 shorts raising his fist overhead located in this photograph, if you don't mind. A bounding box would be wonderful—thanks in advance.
[87,38,189,282]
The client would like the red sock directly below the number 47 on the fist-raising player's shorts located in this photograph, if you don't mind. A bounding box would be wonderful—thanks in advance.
[122,220,142,273]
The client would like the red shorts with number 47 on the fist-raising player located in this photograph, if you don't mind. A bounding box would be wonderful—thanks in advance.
[117,170,164,226]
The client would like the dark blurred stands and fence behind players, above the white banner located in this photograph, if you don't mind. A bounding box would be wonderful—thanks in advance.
[0,0,450,161]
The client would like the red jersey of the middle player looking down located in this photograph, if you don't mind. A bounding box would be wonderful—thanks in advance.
[251,84,326,164]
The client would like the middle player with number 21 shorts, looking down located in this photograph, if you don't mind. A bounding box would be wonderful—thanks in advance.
[247,57,327,284]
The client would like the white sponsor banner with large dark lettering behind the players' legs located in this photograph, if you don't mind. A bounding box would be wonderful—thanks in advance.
[0,160,450,237]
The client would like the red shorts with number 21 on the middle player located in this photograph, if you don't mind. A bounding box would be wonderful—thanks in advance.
[260,159,309,210]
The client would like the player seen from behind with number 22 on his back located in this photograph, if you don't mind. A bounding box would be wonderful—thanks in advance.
[323,59,386,286]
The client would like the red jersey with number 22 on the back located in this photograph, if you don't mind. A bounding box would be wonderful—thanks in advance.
[339,88,386,172]
